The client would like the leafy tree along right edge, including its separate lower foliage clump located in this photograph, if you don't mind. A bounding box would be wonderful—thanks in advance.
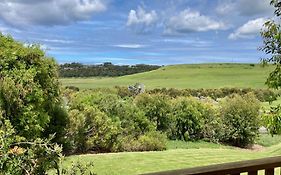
[261,0,281,134]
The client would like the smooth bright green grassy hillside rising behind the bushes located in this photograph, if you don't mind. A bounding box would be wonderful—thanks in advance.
[61,64,273,89]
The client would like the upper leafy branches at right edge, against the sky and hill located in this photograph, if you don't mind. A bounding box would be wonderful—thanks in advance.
[261,0,281,89]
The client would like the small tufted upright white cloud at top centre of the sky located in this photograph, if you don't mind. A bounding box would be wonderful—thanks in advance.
[127,7,158,32]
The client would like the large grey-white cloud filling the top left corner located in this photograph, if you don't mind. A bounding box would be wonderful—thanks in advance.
[0,0,106,27]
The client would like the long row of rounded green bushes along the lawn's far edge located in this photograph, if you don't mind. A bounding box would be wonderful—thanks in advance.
[64,90,260,152]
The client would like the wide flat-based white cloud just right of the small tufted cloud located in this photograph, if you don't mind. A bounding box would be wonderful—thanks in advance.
[164,9,227,34]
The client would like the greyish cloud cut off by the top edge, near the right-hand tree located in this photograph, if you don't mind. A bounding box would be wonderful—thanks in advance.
[216,0,274,16]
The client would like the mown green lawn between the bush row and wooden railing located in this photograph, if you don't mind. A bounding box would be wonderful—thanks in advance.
[58,139,281,175]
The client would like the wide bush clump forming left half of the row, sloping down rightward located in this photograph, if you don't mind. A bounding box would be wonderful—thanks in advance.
[67,91,165,152]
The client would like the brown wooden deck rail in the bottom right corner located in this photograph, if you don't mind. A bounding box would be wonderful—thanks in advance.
[142,156,281,175]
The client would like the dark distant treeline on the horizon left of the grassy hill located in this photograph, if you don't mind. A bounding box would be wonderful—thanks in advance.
[59,62,161,77]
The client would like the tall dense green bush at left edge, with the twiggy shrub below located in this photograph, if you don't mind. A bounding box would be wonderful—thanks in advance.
[0,34,64,175]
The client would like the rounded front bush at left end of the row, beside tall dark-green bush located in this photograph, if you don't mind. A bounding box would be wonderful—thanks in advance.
[67,105,120,152]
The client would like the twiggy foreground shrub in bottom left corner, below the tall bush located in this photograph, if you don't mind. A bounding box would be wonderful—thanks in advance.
[0,118,62,175]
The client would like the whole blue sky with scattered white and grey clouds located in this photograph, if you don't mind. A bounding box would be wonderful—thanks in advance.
[0,0,273,65]
